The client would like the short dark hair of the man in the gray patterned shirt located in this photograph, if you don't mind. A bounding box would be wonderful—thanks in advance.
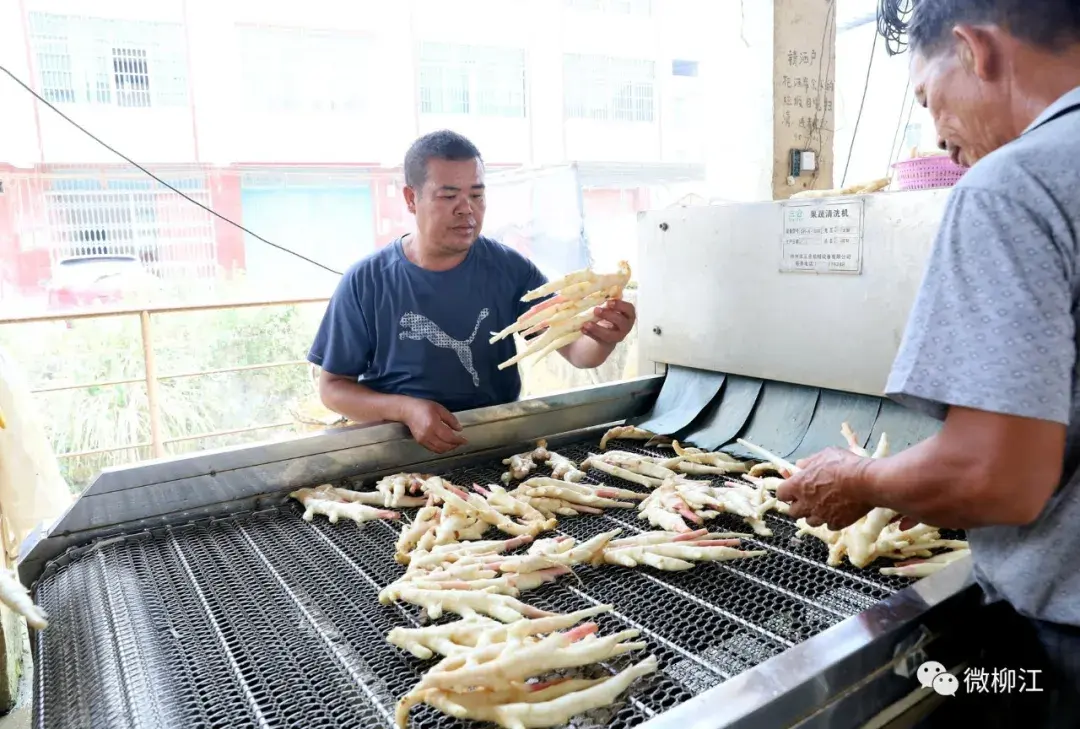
[907,0,1080,56]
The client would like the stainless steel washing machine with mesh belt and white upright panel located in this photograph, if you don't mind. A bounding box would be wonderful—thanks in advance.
[19,192,976,729]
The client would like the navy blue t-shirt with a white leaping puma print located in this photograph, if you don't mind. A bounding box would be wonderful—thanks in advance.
[308,237,548,411]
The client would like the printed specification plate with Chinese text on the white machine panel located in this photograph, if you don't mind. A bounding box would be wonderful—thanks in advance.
[780,200,863,274]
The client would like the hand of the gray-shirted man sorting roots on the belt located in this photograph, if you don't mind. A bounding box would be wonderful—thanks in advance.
[777,448,870,531]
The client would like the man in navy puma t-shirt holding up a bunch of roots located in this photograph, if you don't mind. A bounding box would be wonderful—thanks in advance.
[308,131,636,454]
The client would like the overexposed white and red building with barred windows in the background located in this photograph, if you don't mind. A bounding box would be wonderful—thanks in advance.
[0,0,708,298]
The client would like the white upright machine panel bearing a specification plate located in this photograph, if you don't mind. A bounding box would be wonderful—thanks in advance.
[635,185,949,395]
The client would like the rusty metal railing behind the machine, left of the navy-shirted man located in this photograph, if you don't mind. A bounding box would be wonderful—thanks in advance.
[0,297,329,459]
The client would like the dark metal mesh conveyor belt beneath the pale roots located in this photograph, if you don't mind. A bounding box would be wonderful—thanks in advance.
[33,442,946,729]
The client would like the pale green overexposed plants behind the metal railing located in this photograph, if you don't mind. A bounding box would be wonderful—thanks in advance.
[0,305,323,490]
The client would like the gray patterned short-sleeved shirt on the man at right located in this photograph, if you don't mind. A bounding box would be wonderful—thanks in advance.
[886,87,1080,625]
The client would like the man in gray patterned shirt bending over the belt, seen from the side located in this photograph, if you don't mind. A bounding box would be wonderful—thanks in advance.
[780,0,1080,712]
